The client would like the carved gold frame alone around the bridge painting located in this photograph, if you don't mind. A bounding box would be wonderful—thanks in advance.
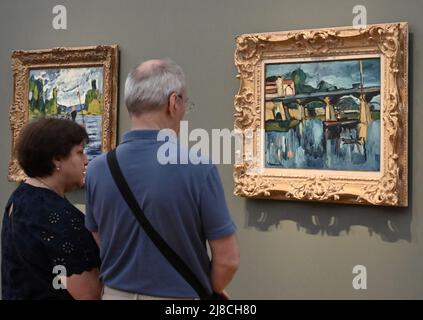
[234,23,408,207]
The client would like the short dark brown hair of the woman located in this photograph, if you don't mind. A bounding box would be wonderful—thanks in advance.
[16,118,88,177]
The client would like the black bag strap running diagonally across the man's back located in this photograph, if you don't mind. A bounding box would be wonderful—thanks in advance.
[107,149,210,299]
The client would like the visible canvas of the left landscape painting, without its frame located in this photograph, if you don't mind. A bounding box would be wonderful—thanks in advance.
[28,67,103,160]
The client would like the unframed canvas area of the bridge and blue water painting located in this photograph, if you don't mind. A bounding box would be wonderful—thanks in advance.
[265,58,381,171]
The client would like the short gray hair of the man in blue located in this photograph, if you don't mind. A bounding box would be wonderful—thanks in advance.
[125,59,185,115]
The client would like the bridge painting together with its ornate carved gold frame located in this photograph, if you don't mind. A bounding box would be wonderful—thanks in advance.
[234,23,408,206]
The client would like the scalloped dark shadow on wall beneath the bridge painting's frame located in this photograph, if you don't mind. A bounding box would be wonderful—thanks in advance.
[246,199,412,242]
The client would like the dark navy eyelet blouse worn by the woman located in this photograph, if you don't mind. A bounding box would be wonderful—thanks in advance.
[1,183,100,300]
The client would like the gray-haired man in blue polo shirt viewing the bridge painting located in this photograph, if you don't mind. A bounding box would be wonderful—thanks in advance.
[85,60,239,299]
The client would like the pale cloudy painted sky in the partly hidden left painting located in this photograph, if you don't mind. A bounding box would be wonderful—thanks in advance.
[30,67,103,106]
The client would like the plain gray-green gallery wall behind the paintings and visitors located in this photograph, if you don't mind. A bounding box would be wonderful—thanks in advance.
[0,0,423,299]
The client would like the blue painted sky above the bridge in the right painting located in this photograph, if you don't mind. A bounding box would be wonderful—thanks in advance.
[266,58,380,89]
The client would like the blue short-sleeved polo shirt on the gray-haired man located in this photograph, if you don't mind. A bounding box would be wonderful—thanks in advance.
[85,130,235,298]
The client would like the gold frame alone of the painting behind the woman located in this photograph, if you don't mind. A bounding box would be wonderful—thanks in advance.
[8,45,118,181]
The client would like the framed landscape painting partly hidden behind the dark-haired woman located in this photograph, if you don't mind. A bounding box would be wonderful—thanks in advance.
[8,45,119,181]
